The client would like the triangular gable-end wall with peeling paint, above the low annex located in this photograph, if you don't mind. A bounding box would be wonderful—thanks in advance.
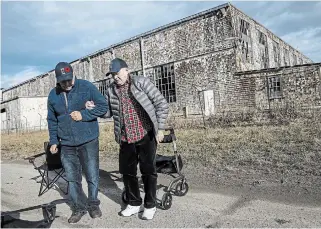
[231,6,312,71]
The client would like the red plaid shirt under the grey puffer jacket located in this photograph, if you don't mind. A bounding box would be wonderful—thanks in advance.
[118,83,152,143]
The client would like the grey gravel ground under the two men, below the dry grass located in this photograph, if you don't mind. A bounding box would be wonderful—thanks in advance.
[1,159,321,228]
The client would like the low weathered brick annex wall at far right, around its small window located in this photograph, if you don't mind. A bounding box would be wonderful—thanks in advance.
[234,64,321,111]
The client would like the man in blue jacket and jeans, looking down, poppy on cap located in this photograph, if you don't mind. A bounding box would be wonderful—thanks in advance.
[47,62,108,223]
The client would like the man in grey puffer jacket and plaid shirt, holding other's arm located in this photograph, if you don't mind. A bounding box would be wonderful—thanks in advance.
[86,58,169,220]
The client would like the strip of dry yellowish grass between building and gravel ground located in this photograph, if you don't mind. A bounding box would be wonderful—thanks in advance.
[1,120,321,175]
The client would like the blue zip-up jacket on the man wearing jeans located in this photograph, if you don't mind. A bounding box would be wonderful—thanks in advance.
[47,78,108,146]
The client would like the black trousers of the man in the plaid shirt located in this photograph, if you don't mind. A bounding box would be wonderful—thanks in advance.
[119,131,157,208]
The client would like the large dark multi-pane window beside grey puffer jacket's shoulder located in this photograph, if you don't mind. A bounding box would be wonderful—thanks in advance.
[150,63,176,103]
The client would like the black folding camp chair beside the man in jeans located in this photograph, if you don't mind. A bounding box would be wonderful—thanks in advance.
[25,142,69,196]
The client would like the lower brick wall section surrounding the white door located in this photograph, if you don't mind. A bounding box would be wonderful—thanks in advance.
[172,49,235,113]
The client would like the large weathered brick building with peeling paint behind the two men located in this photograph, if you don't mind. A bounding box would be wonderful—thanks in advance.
[2,4,321,131]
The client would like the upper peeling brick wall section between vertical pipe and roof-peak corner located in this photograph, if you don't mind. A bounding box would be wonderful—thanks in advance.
[143,6,232,68]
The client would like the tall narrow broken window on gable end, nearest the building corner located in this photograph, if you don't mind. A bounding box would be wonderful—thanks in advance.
[240,19,252,62]
